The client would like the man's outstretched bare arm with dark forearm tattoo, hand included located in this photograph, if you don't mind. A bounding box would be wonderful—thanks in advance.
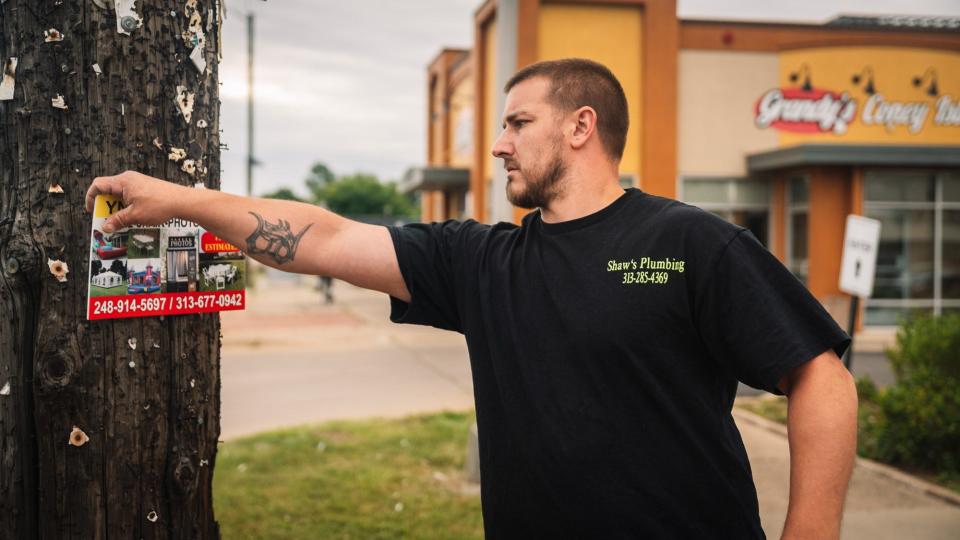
[86,171,410,302]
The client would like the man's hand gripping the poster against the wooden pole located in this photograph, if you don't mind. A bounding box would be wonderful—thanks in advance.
[86,171,189,233]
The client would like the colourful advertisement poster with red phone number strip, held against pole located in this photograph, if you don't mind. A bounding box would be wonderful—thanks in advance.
[87,195,246,320]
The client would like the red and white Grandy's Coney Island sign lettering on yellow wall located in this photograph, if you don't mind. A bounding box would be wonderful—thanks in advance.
[754,87,960,135]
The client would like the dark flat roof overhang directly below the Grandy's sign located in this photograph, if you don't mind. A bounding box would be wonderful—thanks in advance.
[747,144,960,172]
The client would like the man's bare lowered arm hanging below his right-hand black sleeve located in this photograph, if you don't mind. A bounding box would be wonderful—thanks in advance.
[779,350,857,540]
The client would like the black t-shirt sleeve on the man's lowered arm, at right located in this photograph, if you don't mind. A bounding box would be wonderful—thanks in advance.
[696,230,850,394]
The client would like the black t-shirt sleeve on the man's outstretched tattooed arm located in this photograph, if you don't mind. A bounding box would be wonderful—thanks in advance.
[388,220,487,332]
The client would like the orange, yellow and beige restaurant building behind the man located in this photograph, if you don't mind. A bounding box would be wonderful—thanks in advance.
[404,0,960,326]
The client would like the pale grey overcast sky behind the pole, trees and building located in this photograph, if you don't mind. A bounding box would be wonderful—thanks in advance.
[220,0,960,198]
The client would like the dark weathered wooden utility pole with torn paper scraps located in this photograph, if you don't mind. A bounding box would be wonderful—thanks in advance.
[0,0,220,539]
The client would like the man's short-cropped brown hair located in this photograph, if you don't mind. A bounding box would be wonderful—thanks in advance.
[503,58,630,160]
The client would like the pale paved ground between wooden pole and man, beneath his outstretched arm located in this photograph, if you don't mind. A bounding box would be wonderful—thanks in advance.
[221,276,473,439]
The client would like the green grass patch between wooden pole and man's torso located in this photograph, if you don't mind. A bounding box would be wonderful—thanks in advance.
[214,413,483,540]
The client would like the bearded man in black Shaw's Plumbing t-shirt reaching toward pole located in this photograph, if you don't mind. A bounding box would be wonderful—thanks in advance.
[87,59,856,539]
